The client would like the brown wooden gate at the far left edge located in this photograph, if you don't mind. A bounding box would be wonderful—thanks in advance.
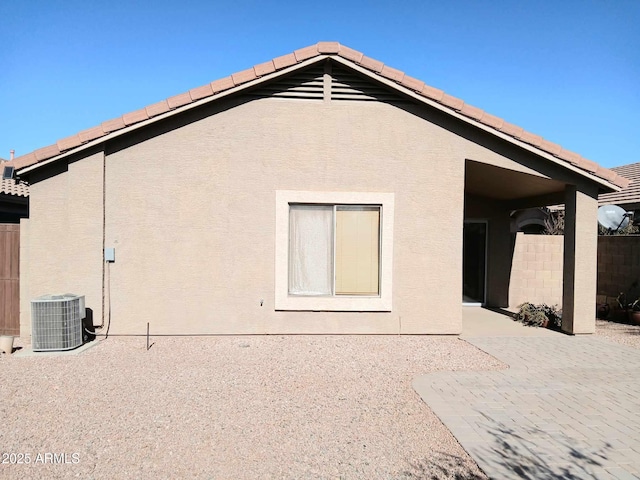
[0,223,20,336]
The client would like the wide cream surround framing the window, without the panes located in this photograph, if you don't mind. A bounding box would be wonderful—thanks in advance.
[275,190,394,312]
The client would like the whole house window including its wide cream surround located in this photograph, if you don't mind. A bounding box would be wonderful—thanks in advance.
[276,191,393,311]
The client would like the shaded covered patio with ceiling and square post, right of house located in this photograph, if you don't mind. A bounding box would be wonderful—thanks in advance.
[463,154,609,334]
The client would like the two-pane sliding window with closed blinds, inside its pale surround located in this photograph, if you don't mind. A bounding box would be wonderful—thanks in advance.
[289,204,380,295]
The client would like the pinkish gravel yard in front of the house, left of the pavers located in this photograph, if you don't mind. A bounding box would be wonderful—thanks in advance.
[0,336,504,479]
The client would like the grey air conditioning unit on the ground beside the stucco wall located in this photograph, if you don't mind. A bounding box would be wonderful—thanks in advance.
[31,293,85,352]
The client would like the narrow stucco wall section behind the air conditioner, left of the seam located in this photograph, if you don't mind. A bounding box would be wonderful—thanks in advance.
[20,152,103,337]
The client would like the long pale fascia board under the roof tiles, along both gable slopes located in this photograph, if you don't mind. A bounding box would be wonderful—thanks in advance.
[17,54,622,192]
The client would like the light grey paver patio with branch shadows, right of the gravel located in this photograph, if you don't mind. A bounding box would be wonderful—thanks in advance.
[413,334,640,479]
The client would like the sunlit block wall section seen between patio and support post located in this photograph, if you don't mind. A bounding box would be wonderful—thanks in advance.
[509,232,564,308]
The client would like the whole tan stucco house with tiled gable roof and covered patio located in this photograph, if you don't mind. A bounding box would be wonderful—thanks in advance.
[15,42,627,335]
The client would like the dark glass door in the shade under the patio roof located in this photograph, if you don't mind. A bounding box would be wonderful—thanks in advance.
[462,221,487,305]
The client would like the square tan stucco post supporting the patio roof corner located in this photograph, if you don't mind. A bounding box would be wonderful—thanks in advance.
[562,185,598,334]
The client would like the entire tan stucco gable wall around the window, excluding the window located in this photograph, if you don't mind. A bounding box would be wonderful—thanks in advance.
[20,94,592,334]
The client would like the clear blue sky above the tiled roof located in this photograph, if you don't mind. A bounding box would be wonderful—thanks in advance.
[0,0,640,167]
